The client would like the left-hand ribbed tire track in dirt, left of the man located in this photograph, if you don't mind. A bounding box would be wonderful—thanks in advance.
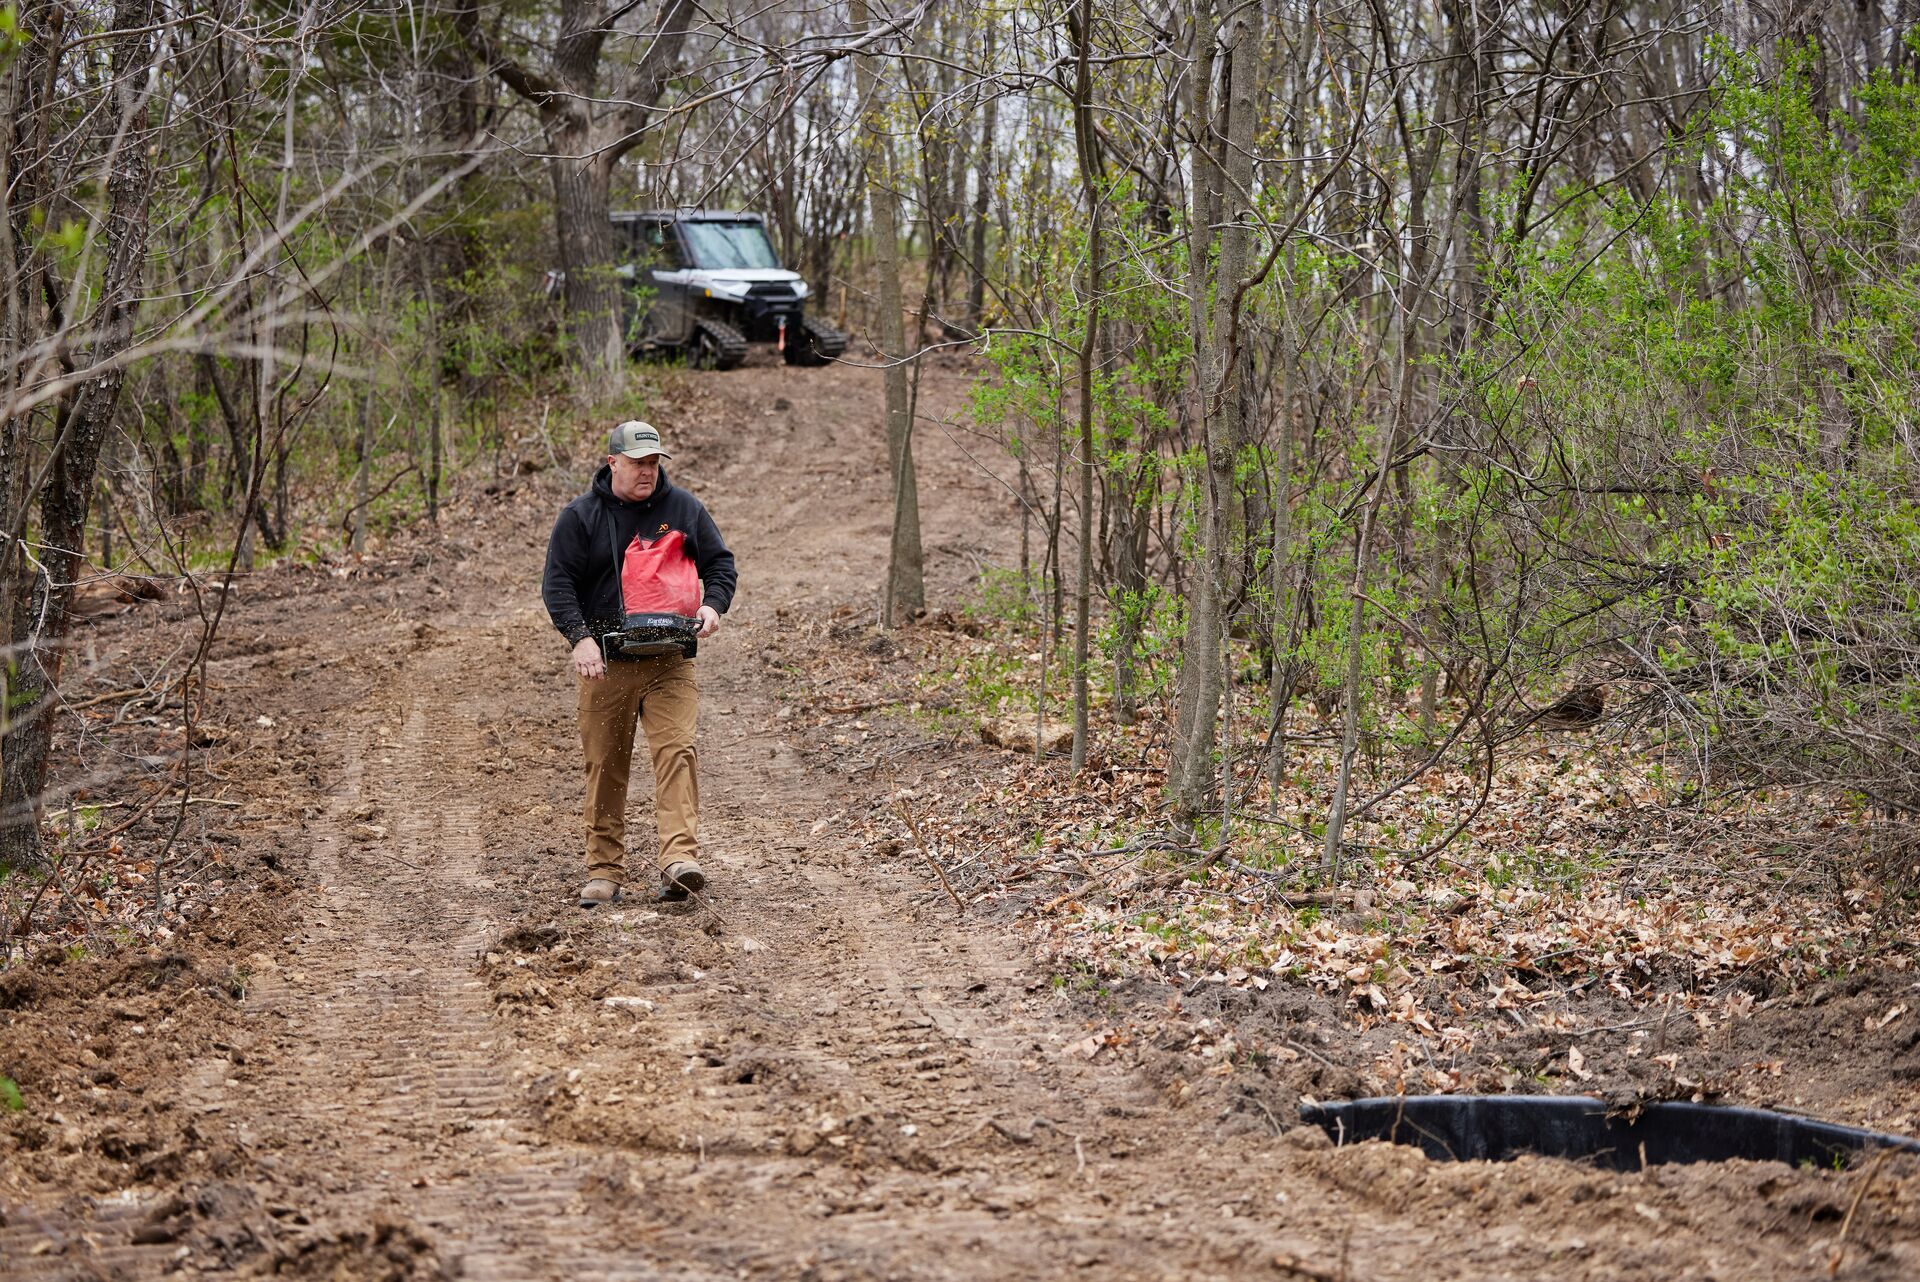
[228,658,687,1280]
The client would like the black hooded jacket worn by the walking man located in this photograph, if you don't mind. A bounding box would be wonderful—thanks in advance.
[540,463,737,645]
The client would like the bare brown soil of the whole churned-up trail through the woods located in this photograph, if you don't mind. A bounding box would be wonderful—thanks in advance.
[0,361,1920,1280]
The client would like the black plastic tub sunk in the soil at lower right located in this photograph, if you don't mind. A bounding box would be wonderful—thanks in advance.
[1300,1096,1920,1171]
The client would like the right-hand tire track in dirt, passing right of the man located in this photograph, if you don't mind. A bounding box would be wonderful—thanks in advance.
[447,427,1344,1278]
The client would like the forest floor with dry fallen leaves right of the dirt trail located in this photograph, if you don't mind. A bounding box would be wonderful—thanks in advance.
[768,570,1920,1098]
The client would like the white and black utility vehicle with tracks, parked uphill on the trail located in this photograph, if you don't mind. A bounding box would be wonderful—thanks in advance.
[612,209,847,370]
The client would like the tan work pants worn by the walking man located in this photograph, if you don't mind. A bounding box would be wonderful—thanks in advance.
[580,654,701,883]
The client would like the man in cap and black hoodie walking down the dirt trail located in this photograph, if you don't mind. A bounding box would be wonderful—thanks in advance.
[541,420,735,908]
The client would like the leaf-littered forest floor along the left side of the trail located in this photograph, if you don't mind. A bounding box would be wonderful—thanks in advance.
[0,395,606,969]
